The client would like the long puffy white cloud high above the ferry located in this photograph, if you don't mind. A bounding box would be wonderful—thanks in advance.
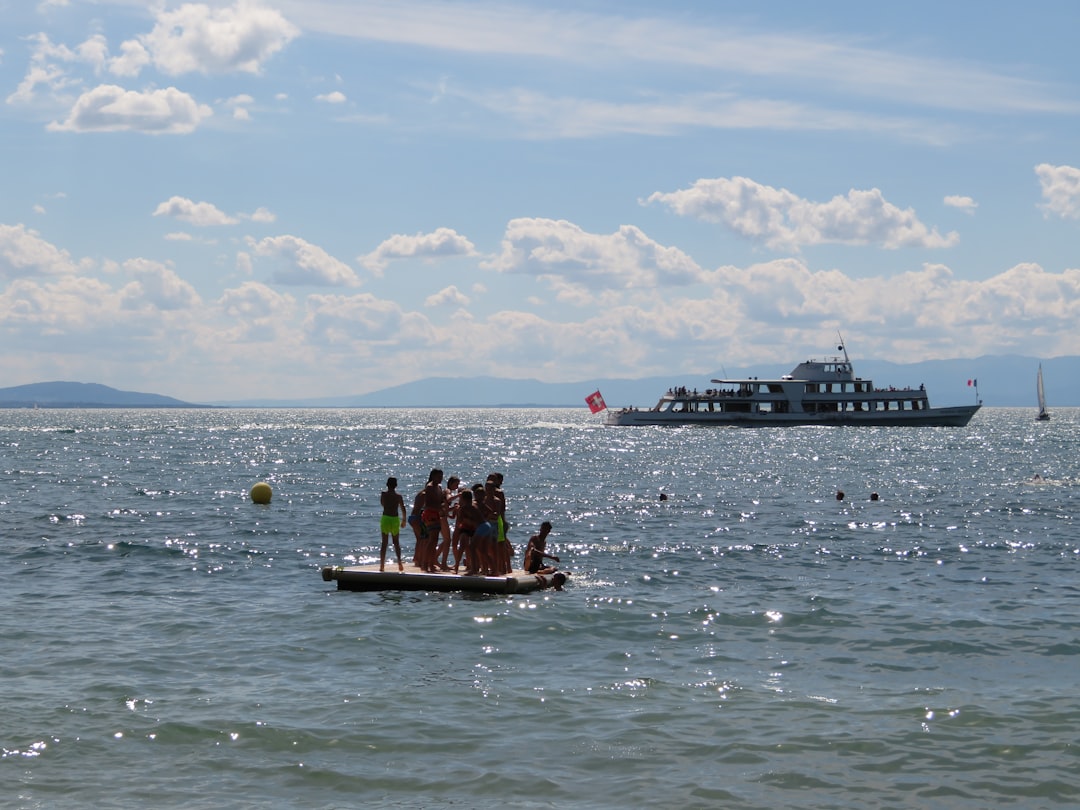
[646,177,959,249]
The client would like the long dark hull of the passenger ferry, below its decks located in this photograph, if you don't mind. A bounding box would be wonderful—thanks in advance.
[604,405,981,428]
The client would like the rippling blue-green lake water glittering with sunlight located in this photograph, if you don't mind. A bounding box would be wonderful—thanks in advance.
[0,408,1080,808]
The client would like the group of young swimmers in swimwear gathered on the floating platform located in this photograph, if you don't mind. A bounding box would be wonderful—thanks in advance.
[379,469,566,590]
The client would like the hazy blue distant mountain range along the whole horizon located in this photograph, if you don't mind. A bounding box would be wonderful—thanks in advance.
[0,355,1080,410]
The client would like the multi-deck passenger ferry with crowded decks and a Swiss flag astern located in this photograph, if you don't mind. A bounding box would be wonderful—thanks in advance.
[604,343,982,428]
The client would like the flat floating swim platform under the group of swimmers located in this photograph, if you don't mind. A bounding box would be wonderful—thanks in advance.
[323,562,552,594]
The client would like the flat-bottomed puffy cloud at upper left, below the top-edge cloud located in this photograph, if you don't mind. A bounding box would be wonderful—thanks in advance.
[48,84,214,135]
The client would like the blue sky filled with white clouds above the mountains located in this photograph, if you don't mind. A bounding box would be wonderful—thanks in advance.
[0,0,1080,402]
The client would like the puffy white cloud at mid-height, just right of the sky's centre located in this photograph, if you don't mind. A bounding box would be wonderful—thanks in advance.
[484,218,708,293]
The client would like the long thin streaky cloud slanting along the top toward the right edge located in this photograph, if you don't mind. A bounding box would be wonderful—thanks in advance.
[279,0,1077,113]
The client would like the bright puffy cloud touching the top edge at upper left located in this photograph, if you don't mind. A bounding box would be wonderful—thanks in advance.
[125,0,299,76]
